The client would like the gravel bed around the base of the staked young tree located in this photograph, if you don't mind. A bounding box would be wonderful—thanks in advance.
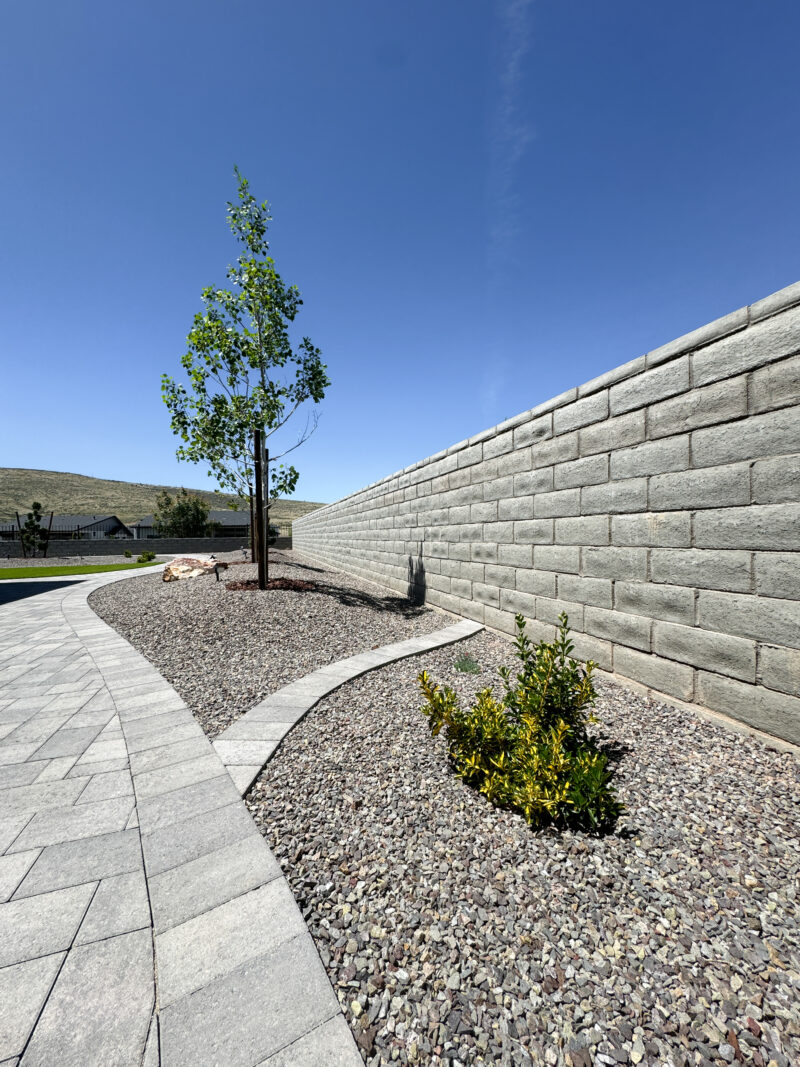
[89,552,448,738]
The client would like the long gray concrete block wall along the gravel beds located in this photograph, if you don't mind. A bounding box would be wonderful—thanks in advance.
[292,283,800,744]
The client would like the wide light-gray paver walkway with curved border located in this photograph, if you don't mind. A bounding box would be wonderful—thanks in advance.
[0,572,482,1067]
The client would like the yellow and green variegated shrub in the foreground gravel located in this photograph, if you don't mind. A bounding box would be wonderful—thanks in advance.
[418,614,624,832]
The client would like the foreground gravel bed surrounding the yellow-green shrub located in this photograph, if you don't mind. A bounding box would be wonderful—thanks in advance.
[246,627,800,1067]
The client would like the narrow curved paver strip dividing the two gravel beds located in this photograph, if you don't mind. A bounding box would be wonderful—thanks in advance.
[213,620,483,796]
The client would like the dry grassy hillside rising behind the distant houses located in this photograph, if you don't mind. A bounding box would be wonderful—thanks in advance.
[0,467,322,523]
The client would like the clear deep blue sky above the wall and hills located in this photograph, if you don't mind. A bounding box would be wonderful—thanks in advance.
[0,0,800,500]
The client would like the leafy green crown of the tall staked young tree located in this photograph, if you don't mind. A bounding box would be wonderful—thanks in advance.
[161,168,330,498]
